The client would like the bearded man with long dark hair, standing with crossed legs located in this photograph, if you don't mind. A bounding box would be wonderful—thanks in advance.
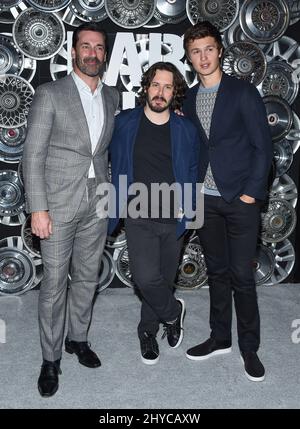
[109,62,199,365]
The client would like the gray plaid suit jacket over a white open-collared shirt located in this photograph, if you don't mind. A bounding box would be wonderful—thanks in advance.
[22,75,119,222]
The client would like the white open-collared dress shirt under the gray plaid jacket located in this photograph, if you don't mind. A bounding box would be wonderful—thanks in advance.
[71,71,104,178]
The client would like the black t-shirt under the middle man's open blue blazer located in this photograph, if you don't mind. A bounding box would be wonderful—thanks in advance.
[133,113,176,223]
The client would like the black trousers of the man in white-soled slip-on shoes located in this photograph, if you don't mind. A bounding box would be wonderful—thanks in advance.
[198,195,260,351]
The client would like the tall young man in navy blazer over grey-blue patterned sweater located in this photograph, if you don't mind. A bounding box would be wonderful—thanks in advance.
[183,21,272,381]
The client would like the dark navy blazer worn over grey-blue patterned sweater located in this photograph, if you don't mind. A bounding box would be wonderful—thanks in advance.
[183,73,273,202]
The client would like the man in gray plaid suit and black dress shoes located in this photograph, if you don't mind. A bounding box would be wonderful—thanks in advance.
[23,23,119,397]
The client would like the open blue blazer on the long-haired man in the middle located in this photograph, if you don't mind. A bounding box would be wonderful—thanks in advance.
[108,107,200,237]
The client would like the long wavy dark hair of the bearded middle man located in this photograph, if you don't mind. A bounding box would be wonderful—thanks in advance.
[138,61,187,110]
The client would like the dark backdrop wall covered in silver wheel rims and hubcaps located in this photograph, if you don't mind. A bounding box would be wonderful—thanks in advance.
[0,0,300,289]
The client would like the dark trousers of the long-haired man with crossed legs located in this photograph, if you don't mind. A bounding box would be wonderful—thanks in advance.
[125,219,183,338]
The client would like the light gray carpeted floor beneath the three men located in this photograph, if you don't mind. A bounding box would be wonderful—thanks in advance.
[0,284,300,409]
